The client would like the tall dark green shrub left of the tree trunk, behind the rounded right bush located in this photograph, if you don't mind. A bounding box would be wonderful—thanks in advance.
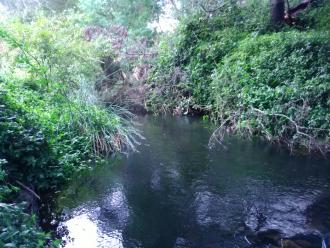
[147,1,268,113]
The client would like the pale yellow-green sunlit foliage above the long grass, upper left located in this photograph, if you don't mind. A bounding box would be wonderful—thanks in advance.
[0,12,111,91]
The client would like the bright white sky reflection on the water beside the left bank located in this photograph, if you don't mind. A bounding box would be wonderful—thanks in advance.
[63,185,129,248]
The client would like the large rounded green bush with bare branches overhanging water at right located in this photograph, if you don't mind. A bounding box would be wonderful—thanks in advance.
[212,31,330,151]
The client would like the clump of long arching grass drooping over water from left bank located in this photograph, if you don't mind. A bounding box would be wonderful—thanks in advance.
[60,74,143,155]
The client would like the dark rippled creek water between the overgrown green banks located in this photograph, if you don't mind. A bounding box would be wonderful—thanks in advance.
[60,117,330,248]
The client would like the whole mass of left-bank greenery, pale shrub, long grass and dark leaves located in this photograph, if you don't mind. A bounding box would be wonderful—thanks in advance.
[0,12,138,247]
